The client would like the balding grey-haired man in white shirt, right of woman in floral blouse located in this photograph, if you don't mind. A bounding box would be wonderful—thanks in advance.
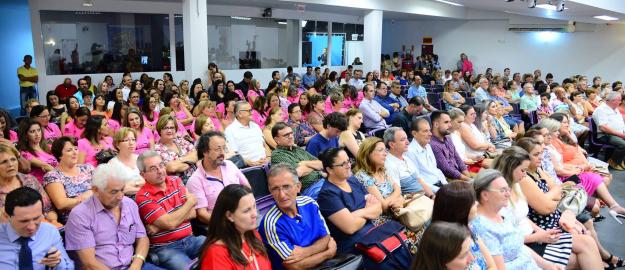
[384,127,434,197]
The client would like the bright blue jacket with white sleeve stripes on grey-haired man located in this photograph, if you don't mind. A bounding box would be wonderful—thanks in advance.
[258,196,330,270]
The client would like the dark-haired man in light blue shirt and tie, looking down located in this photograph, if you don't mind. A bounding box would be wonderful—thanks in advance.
[0,187,74,270]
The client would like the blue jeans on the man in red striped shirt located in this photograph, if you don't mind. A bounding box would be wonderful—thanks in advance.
[148,235,206,269]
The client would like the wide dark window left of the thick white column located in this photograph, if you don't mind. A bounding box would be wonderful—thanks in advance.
[41,11,171,75]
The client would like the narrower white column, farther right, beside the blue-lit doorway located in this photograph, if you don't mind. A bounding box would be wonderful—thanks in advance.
[362,10,383,74]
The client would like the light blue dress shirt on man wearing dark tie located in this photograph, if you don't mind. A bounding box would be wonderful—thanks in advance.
[0,222,74,270]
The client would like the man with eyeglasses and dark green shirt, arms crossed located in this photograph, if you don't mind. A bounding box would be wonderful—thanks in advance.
[271,122,323,189]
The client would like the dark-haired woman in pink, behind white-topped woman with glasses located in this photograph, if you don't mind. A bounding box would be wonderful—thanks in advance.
[78,115,113,167]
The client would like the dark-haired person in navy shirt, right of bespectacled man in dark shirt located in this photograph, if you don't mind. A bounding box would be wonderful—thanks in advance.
[306,112,347,156]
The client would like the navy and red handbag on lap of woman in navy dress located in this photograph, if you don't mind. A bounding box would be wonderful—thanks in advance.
[356,220,412,269]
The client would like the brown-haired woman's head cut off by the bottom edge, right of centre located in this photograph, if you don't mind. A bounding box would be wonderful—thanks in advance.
[410,221,470,270]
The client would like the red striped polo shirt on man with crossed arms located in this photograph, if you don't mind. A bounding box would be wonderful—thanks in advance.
[135,176,193,246]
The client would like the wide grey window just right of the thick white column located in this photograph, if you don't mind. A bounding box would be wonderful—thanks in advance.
[208,16,299,69]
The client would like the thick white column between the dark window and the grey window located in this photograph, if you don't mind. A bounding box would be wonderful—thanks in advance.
[182,0,208,82]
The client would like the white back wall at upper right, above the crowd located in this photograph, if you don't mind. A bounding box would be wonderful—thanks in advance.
[382,20,625,81]
